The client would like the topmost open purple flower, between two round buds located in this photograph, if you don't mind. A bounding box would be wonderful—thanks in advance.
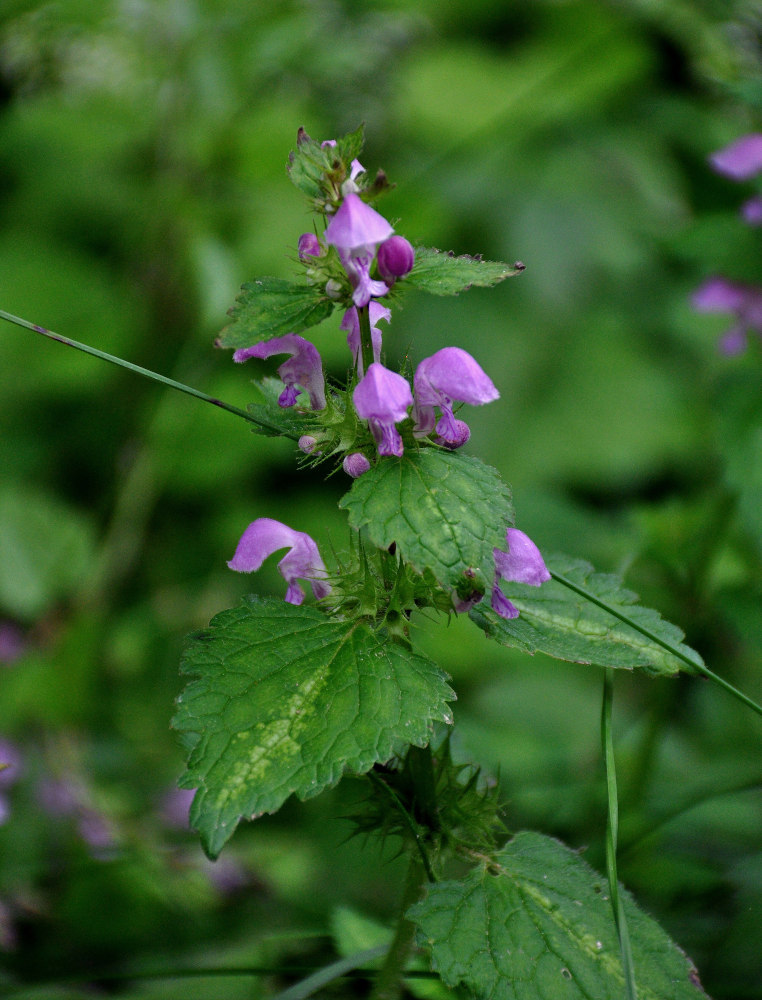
[324,191,394,306]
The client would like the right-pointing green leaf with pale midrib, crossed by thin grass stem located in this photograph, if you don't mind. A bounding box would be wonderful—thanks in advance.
[469,555,703,675]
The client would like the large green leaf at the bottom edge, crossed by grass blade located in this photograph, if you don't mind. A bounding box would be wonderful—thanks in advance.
[407,832,706,1000]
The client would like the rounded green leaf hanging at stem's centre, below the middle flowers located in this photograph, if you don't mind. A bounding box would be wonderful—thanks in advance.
[339,448,513,590]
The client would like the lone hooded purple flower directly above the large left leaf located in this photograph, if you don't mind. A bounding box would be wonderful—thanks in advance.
[228,517,331,604]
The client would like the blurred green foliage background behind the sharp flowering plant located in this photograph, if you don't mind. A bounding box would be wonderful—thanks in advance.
[0,0,762,1000]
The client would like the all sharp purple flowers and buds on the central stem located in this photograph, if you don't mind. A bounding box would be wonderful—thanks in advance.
[228,140,550,618]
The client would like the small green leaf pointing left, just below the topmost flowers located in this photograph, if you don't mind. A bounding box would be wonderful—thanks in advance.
[217,278,335,350]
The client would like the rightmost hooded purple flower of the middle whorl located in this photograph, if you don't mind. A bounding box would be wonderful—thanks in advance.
[413,347,500,448]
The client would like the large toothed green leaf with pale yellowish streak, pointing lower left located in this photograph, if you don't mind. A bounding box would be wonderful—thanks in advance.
[173,596,455,857]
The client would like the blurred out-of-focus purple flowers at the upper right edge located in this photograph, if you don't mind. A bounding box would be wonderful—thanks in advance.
[692,133,762,355]
